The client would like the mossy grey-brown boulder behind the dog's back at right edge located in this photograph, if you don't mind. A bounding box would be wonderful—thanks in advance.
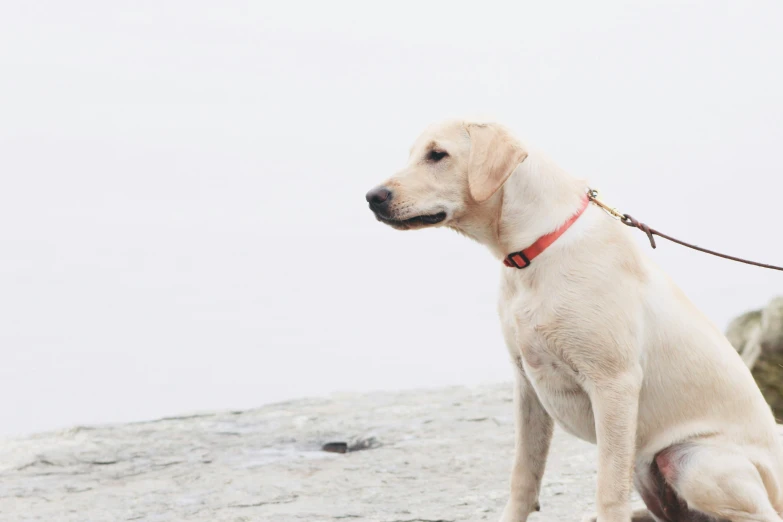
[726,297,783,416]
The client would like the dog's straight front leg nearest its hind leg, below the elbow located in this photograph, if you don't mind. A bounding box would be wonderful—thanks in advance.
[586,371,642,522]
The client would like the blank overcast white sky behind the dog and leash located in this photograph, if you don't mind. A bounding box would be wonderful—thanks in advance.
[0,0,783,434]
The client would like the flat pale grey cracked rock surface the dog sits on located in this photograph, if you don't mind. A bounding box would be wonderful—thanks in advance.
[0,384,636,522]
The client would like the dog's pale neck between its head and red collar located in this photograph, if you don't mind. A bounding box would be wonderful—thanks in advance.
[460,153,587,259]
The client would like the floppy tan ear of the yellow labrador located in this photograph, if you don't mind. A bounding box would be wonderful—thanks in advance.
[466,123,527,203]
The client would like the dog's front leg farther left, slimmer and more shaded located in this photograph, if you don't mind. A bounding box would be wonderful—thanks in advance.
[501,367,554,522]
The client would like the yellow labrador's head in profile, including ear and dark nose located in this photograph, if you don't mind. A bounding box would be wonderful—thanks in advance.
[367,122,527,230]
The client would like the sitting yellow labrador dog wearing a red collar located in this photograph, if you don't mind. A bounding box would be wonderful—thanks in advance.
[367,121,783,522]
